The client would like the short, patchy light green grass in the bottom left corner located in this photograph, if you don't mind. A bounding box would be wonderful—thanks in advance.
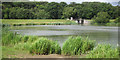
[2,46,29,58]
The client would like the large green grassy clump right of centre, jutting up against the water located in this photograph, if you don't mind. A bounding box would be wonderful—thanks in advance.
[62,36,94,55]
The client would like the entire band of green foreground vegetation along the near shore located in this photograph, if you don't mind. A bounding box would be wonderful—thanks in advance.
[2,27,119,58]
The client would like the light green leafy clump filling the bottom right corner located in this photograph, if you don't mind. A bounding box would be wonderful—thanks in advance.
[87,44,119,58]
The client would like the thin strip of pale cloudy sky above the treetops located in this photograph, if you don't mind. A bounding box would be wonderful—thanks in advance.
[30,0,120,3]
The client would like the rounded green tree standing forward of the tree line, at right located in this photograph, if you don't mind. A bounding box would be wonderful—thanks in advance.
[93,12,110,24]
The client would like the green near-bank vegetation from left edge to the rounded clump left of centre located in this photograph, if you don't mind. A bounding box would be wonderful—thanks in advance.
[2,28,61,55]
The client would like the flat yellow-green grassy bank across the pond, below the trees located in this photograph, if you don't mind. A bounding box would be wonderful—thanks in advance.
[2,19,76,26]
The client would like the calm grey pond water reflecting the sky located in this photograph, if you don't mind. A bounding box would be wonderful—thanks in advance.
[11,25,118,46]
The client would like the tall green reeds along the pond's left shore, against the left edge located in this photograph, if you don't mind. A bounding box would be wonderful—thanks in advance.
[2,28,38,46]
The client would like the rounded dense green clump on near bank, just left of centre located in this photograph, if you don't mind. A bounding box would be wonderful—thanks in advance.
[30,37,61,55]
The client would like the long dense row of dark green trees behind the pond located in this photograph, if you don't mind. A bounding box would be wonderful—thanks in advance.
[2,2,120,19]
